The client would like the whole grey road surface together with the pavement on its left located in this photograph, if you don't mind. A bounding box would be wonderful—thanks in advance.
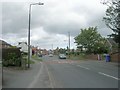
[3,56,119,88]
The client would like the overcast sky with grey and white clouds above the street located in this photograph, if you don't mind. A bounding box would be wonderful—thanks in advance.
[0,0,112,49]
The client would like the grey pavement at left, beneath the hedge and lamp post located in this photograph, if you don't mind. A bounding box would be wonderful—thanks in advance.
[3,58,51,88]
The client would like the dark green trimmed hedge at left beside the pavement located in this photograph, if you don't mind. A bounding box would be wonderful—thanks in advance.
[2,48,21,66]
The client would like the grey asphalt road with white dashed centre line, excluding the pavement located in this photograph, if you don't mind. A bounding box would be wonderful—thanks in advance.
[43,56,119,88]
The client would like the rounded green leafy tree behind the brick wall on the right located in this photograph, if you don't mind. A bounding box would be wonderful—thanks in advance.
[75,27,106,53]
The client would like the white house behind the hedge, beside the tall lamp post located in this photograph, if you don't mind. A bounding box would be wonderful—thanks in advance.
[17,42,32,55]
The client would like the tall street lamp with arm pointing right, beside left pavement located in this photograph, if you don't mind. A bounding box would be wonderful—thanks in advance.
[28,2,44,68]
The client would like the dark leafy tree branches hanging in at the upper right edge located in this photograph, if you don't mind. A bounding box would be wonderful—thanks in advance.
[103,0,120,48]
